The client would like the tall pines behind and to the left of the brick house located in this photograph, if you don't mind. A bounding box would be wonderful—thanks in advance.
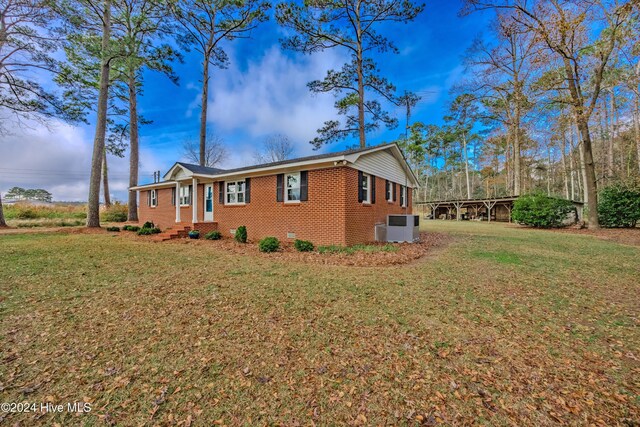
[0,0,424,227]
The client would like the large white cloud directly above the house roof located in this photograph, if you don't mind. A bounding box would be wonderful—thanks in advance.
[208,45,344,166]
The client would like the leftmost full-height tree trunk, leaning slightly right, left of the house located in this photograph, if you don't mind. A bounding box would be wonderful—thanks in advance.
[87,0,111,227]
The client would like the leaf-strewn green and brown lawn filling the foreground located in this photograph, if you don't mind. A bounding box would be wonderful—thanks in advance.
[0,221,640,426]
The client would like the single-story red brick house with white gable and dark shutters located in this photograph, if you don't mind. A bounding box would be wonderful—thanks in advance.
[131,144,417,245]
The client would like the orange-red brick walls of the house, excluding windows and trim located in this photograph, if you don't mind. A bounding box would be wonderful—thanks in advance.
[138,166,412,245]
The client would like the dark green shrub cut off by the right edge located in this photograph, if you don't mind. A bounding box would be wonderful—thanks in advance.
[598,185,640,228]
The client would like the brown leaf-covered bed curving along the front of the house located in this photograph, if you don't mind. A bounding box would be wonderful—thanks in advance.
[156,232,452,267]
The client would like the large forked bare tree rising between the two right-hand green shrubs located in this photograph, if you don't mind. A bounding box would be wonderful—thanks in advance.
[460,0,633,228]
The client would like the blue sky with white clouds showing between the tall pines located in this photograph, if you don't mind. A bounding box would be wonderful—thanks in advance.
[0,1,489,200]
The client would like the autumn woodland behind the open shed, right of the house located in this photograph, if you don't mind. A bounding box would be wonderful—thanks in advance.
[399,0,640,231]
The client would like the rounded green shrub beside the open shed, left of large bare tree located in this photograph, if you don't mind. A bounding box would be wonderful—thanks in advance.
[511,193,575,228]
